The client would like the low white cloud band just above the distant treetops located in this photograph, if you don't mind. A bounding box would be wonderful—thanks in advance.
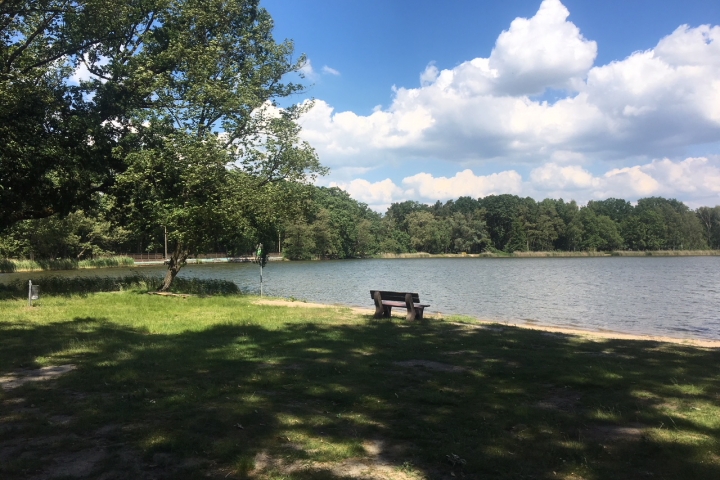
[331,156,720,212]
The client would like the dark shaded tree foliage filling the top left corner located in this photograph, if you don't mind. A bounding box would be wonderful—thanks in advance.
[0,0,169,231]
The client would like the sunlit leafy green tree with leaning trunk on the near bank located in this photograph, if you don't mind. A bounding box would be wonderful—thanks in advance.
[115,0,325,290]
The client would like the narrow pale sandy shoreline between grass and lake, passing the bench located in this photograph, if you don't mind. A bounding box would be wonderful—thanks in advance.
[253,298,720,348]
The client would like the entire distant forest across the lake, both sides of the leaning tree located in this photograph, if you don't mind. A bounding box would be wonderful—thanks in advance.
[0,187,720,260]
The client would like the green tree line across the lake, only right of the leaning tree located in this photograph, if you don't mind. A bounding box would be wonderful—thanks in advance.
[284,188,720,259]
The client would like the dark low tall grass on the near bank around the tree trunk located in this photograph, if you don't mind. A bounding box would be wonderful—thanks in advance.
[0,274,240,298]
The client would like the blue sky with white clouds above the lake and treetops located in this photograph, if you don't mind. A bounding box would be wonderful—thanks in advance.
[261,0,720,212]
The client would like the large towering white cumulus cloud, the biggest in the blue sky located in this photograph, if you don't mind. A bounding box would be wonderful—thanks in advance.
[302,0,720,175]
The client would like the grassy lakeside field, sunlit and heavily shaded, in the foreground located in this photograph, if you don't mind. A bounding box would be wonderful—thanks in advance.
[0,291,720,479]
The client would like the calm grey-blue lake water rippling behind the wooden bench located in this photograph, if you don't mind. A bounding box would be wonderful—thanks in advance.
[5,257,720,340]
